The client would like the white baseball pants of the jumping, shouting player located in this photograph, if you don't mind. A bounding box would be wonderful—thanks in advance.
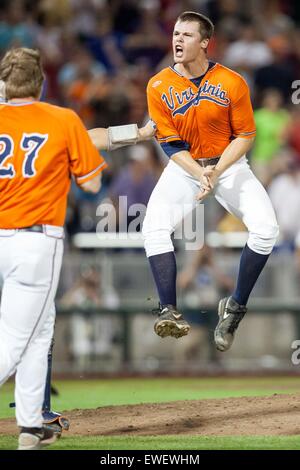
[143,156,279,257]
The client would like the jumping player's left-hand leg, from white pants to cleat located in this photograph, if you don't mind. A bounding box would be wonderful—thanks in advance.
[143,161,199,338]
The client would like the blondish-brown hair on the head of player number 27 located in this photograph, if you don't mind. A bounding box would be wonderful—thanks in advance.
[0,47,45,100]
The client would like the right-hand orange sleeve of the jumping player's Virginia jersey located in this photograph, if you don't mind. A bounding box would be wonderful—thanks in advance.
[230,77,256,139]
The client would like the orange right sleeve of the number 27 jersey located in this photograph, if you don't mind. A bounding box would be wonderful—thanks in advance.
[67,111,107,184]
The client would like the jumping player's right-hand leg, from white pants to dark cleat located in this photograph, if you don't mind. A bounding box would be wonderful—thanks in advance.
[215,161,278,351]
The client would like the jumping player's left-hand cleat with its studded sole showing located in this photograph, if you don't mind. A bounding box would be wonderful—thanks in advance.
[154,305,191,338]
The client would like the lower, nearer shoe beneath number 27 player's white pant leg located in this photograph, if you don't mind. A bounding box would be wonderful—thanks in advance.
[18,427,57,450]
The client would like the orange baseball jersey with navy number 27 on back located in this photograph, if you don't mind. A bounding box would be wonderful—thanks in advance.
[0,101,107,229]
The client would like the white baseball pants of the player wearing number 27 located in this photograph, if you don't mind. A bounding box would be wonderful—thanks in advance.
[0,226,63,427]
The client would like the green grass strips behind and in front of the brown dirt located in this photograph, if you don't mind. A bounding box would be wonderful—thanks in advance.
[0,377,300,450]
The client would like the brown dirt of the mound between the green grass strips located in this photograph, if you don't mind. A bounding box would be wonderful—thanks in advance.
[0,394,300,436]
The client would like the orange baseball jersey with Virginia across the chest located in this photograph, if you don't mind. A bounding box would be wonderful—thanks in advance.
[147,62,255,159]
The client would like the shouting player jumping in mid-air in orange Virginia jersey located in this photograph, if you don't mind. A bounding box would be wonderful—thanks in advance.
[143,12,278,351]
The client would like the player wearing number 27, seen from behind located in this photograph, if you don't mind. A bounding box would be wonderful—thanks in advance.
[0,48,106,450]
